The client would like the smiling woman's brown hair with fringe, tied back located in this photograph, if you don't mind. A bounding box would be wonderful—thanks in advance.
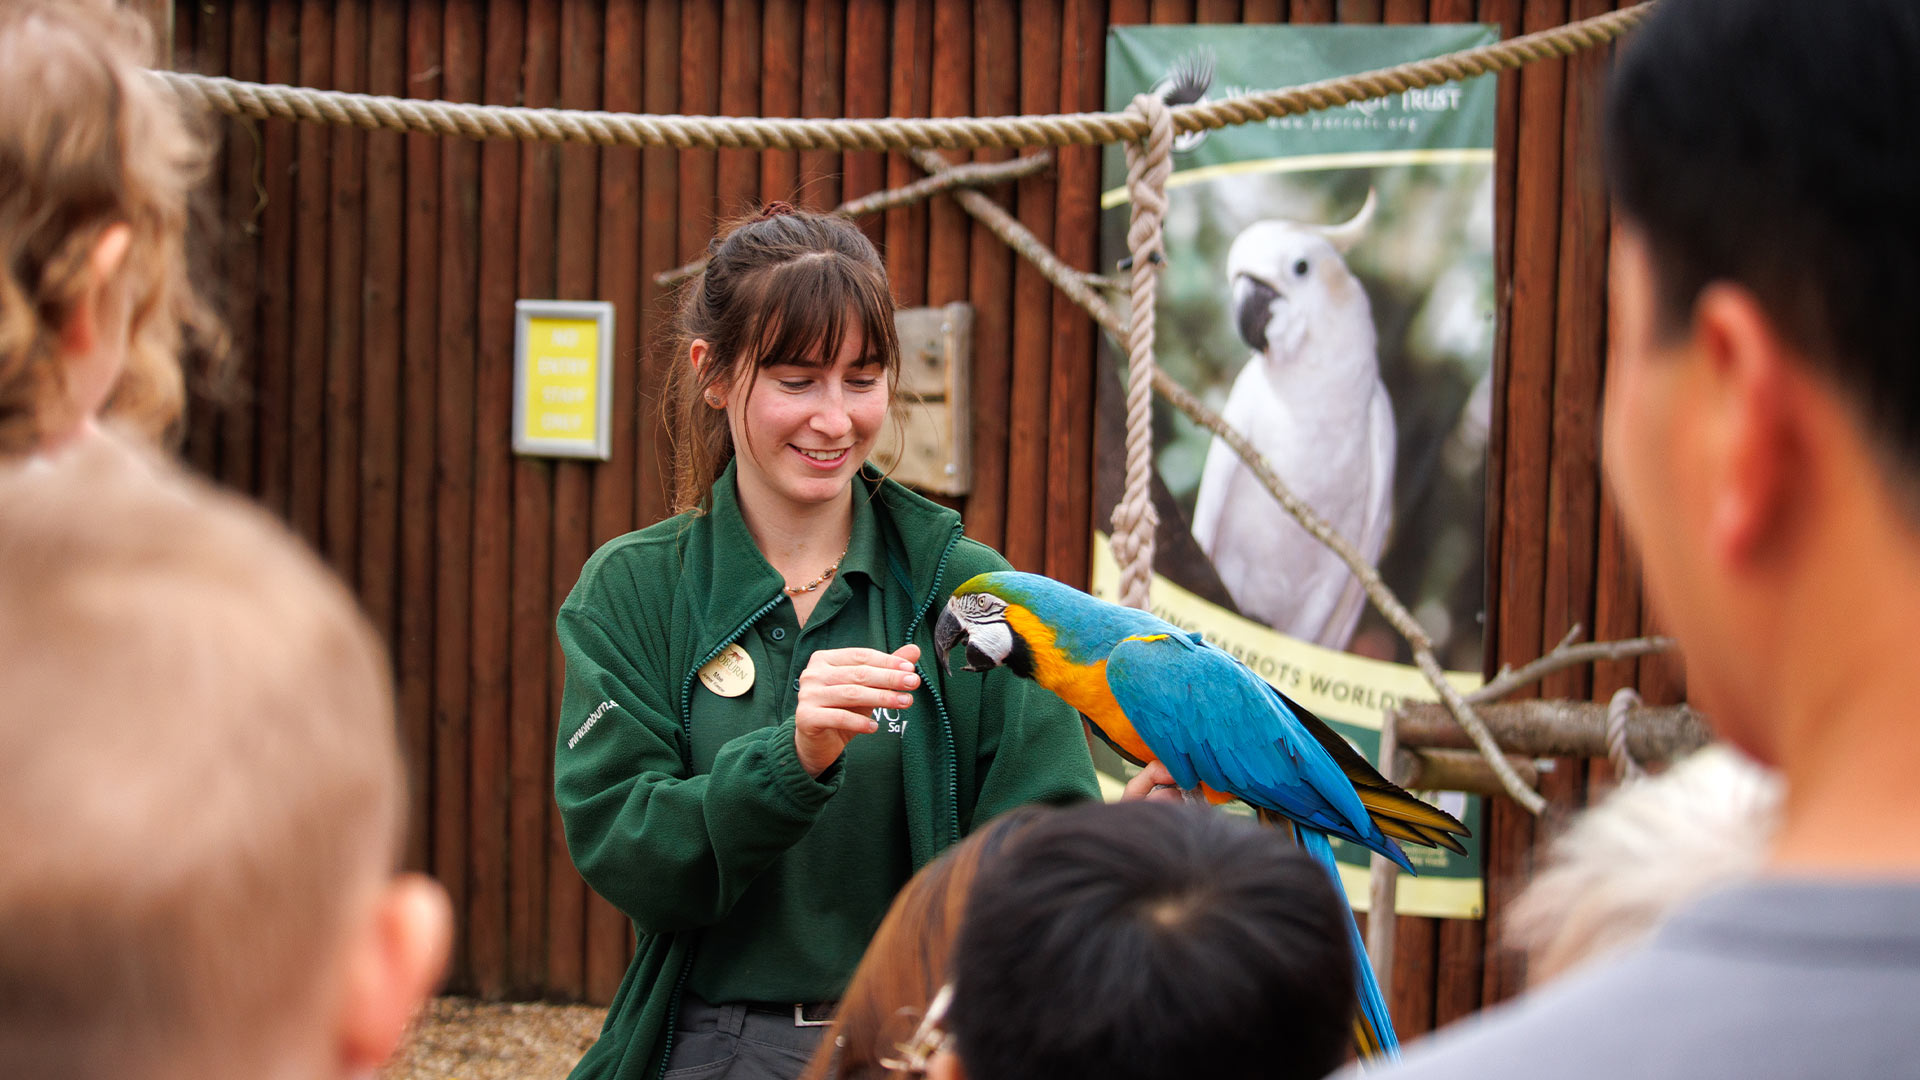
[666,202,900,511]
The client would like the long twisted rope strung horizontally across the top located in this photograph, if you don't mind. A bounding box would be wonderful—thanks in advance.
[152,0,1653,150]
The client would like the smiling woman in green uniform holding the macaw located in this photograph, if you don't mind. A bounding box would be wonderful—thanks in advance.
[555,204,1096,1080]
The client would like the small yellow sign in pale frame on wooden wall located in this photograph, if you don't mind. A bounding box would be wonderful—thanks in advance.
[513,300,612,459]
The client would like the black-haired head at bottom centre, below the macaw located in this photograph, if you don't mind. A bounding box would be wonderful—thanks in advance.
[947,803,1354,1080]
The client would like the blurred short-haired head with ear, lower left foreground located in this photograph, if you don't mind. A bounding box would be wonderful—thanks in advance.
[0,436,445,1080]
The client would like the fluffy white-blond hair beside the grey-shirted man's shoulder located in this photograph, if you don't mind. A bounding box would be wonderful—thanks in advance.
[1507,746,1780,982]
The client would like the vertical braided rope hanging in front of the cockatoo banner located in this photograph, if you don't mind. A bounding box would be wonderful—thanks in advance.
[1114,94,1173,611]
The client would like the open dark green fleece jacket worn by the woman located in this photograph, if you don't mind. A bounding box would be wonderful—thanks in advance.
[553,469,1098,1080]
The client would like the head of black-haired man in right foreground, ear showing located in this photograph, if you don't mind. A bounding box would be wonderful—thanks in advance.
[1603,0,1920,763]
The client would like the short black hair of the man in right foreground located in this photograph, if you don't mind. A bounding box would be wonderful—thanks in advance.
[1607,0,1920,495]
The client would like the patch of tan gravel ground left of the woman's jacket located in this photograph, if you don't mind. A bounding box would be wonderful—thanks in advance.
[380,997,607,1080]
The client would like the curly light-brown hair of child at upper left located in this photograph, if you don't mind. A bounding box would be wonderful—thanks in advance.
[0,0,225,455]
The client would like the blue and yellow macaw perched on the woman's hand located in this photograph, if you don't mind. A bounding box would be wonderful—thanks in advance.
[933,571,1467,1057]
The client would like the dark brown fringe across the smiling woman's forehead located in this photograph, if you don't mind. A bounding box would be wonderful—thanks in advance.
[747,252,900,376]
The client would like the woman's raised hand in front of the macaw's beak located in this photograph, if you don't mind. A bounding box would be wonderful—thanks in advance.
[793,646,920,776]
